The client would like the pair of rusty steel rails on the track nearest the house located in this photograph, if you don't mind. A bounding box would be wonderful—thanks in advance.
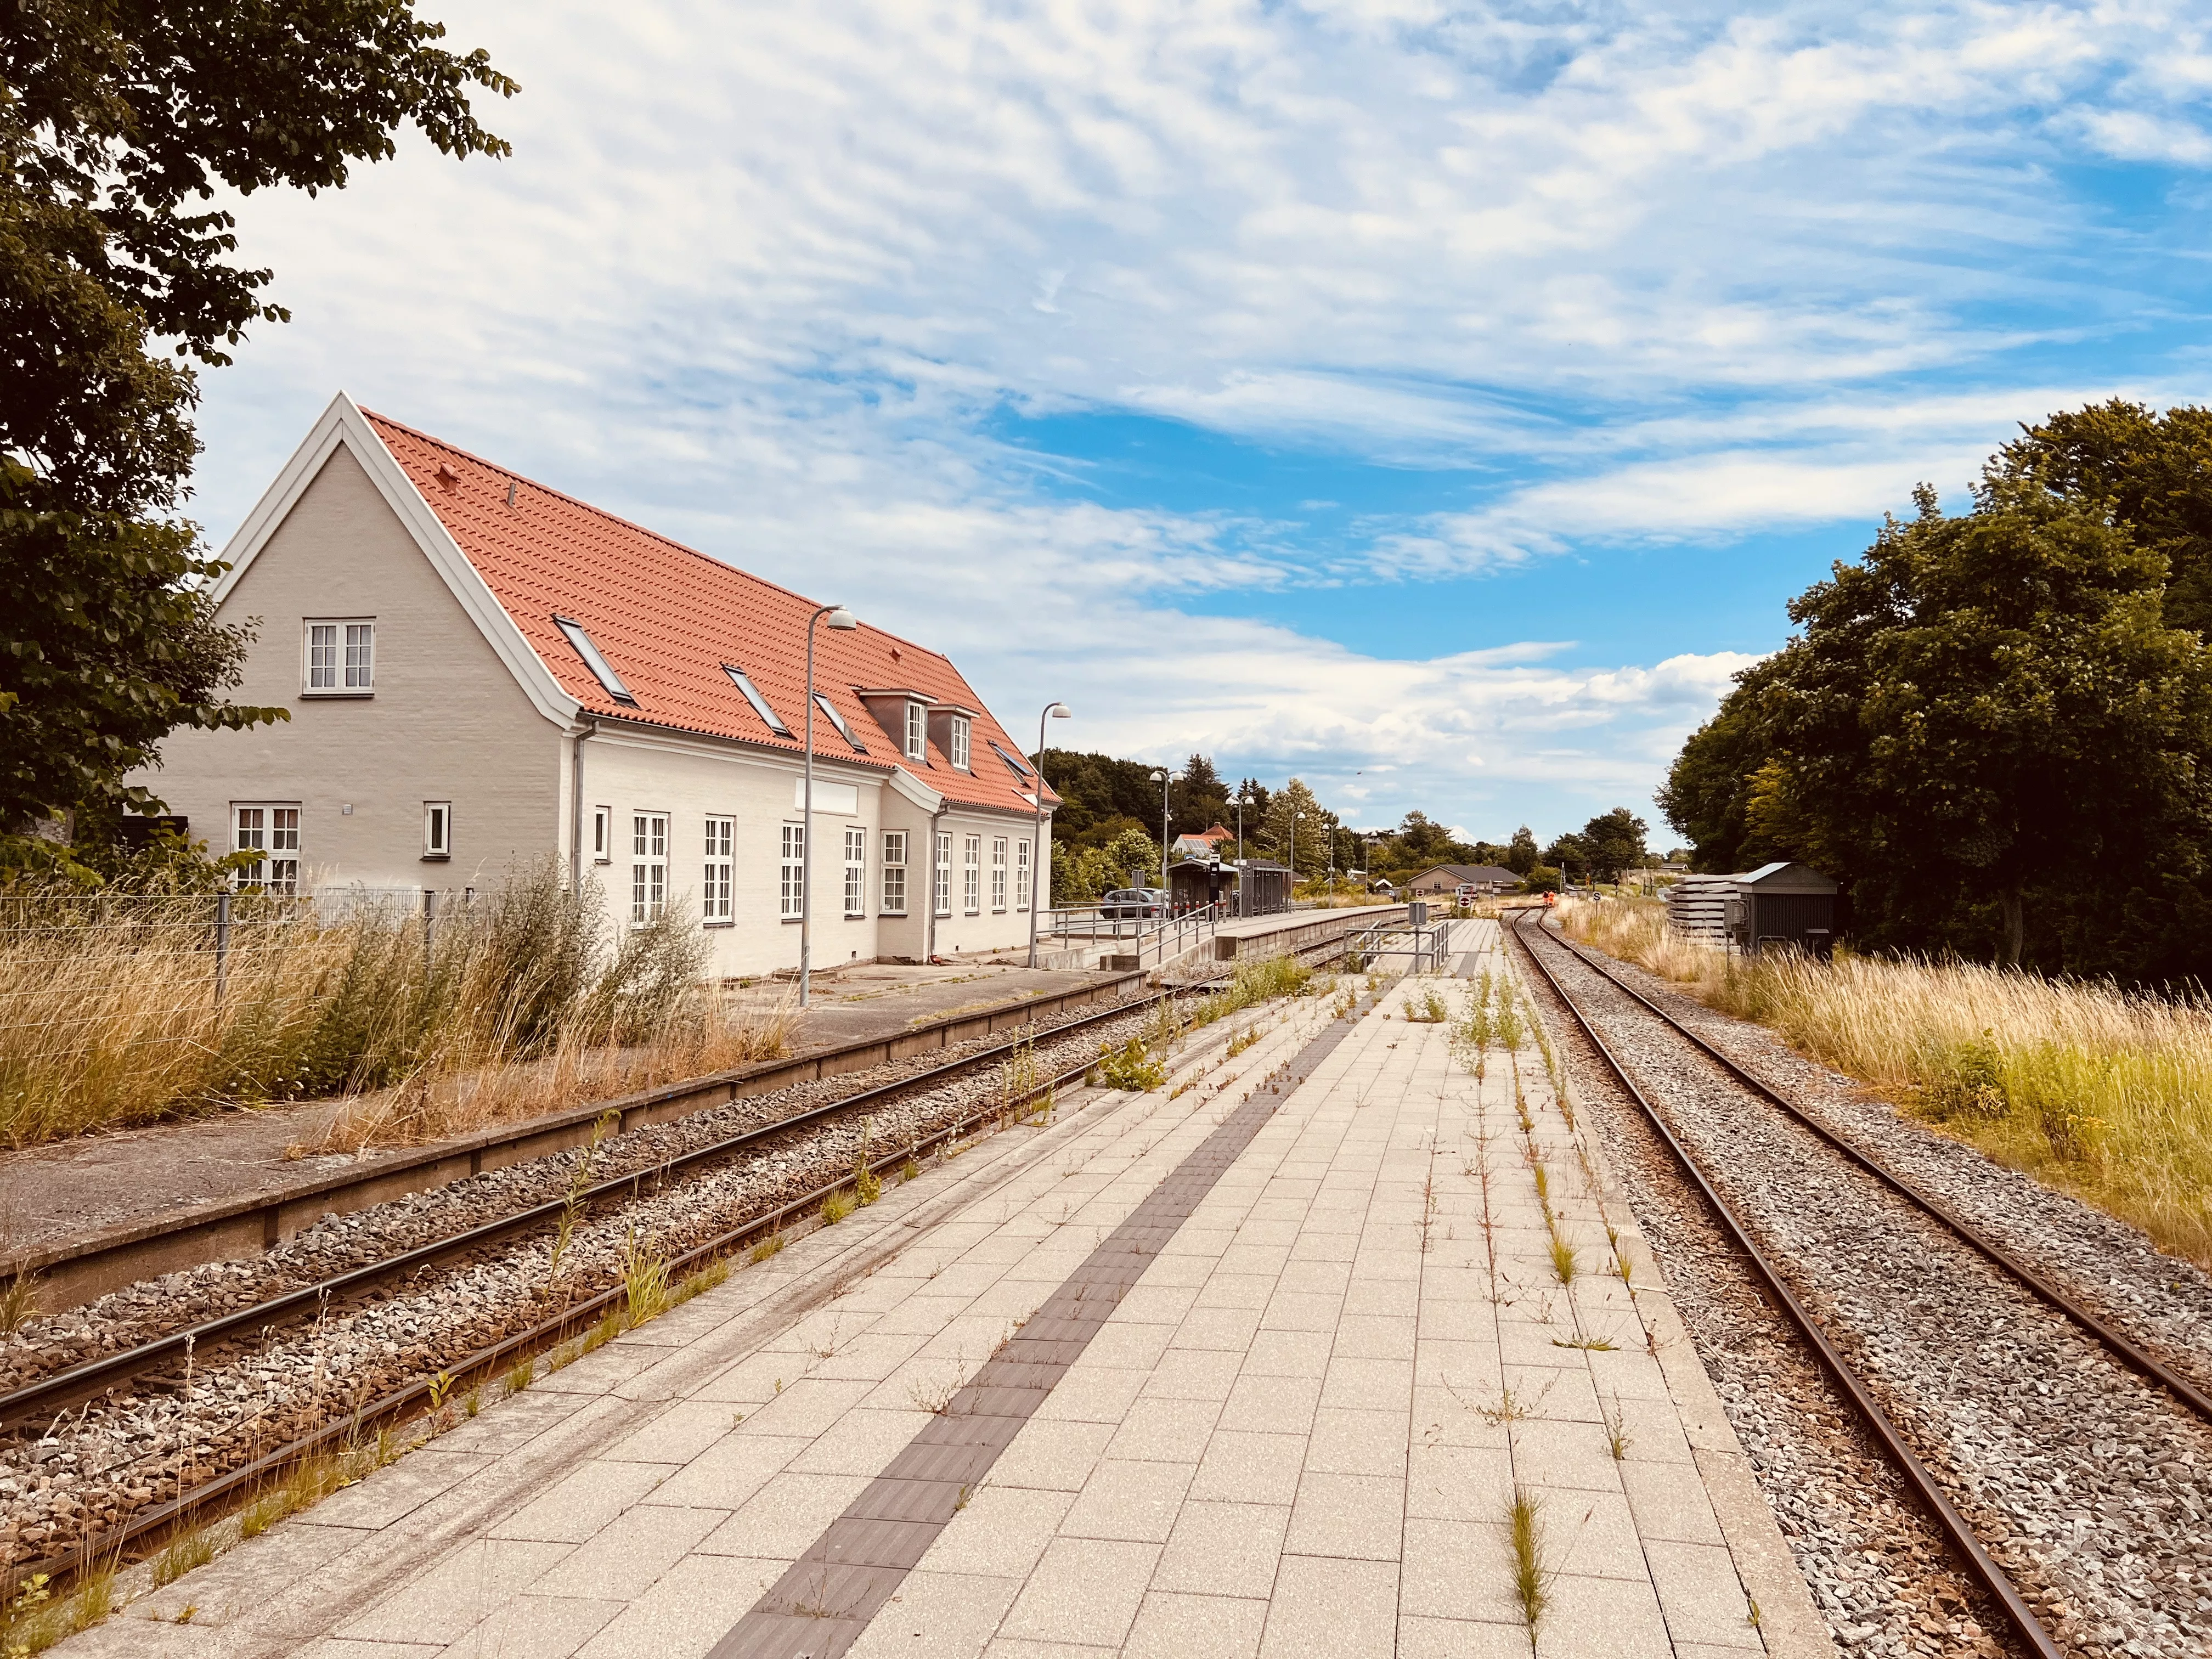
[0,940,1342,1593]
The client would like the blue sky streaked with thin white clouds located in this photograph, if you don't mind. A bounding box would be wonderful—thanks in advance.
[193,0,2212,847]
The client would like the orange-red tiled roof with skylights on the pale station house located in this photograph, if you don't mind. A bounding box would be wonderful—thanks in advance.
[363,409,1057,812]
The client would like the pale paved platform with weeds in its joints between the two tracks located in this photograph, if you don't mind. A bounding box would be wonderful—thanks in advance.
[64,922,1827,1659]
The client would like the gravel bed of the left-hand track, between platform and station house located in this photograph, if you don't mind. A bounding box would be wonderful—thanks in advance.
[0,962,1345,1645]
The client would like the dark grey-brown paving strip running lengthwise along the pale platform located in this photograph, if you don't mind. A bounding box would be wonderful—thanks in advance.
[708,1011,1358,1659]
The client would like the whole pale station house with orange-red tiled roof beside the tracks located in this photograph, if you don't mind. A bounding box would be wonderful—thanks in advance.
[142,394,1057,973]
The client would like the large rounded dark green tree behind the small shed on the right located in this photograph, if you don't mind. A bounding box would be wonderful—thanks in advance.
[1661,469,2212,978]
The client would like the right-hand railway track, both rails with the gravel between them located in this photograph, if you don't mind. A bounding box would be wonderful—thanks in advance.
[1506,911,2212,1659]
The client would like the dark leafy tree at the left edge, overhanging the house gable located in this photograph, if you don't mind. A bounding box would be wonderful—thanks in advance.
[0,0,515,845]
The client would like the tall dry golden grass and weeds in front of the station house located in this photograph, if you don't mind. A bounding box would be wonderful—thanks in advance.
[0,865,787,1146]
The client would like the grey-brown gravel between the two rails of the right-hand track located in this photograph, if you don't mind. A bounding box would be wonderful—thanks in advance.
[1531,916,2212,1655]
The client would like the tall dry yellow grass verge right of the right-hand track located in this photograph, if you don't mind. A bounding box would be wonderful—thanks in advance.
[1560,902,2212,1267]
